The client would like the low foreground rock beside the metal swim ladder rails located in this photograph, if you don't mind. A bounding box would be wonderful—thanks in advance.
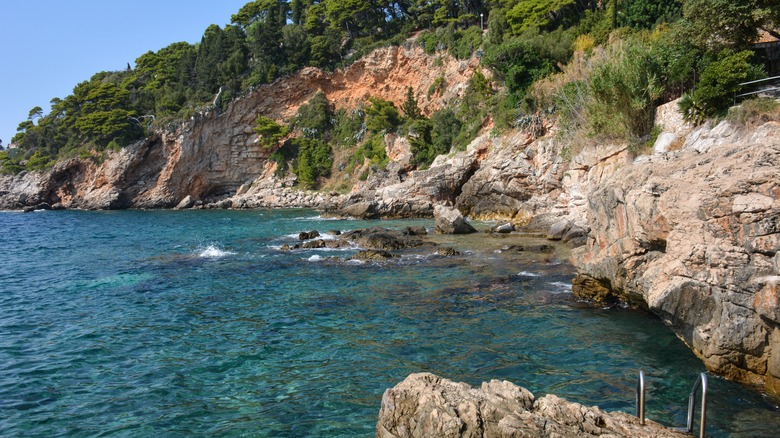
[376,373,688,438]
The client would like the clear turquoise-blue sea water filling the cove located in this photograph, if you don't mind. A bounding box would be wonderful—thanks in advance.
[0,211,780,437]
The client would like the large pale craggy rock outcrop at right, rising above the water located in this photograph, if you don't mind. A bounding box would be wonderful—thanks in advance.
[572,122,780,393]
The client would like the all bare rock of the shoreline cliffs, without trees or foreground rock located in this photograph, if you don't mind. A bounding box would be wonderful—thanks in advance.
[0,42,780,402]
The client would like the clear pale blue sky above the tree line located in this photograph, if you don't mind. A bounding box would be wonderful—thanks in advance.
[0,0,249,147]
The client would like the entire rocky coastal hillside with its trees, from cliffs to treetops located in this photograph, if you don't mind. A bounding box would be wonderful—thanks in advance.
[0,0,780,400]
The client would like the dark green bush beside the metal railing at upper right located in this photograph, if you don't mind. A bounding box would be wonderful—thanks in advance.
[680,49,764,124]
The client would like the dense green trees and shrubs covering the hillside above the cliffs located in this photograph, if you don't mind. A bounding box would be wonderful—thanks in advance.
[0,0,780,178]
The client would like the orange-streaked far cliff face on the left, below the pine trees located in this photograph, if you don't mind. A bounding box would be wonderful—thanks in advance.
[0,44,477,209]
